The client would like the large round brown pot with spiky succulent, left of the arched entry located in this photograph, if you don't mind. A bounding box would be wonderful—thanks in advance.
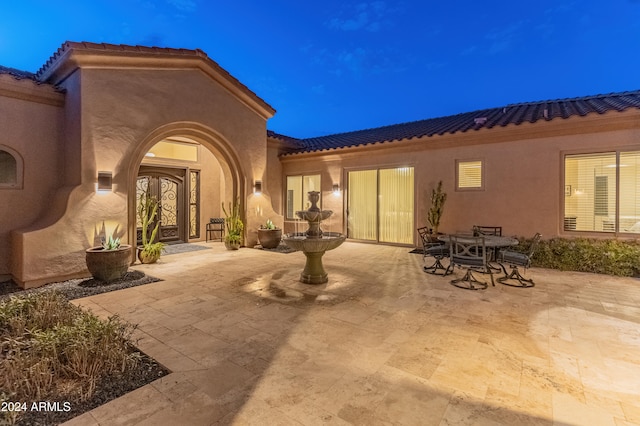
[85,235,131,283]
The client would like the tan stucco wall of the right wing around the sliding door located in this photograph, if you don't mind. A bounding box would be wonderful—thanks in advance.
[282,110,640,243]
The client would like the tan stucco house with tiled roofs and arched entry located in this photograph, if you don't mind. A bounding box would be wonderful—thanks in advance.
[0,42,640,287]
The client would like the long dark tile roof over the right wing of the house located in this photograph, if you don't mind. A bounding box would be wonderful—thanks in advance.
[284,90,640,155]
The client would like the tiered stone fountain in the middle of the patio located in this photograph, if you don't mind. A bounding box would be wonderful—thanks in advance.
[283,191,347,284]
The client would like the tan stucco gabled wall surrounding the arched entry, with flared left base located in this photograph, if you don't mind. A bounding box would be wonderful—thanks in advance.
[12,64,276,286]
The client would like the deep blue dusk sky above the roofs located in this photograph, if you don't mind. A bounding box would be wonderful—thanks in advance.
[0,0,640,138]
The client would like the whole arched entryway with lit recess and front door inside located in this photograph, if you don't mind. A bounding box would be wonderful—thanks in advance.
[127,123,246,253]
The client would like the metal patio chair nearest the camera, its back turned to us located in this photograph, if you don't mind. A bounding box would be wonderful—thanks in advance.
[447,235,495,290]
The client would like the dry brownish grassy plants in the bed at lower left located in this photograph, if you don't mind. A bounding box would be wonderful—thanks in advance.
[0,291,140,422]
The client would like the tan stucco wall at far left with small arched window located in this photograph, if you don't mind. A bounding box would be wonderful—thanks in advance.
[0,75,64,280]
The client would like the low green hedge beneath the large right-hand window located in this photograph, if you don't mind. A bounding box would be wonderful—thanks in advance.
[518,238,640,277]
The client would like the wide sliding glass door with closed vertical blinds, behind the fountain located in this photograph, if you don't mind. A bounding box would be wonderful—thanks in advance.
[347,167,414,244]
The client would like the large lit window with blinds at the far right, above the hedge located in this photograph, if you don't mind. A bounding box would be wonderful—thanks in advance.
[564,151,640,233]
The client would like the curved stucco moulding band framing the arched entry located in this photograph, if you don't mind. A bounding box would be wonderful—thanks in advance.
[125,122,247,253]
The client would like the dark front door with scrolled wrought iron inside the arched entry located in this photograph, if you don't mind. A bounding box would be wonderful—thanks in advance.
[136,167,186,243]
